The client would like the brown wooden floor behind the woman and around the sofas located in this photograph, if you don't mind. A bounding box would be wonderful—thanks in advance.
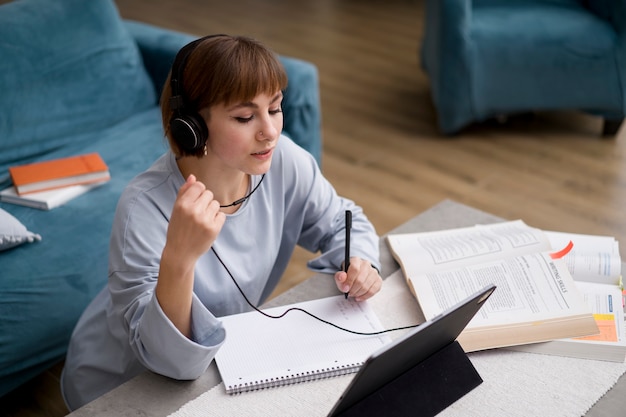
[0,0,626,417]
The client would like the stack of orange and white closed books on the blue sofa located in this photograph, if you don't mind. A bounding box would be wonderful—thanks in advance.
[0,153,111,210]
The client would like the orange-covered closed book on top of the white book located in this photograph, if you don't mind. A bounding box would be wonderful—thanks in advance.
[9,153,111,195]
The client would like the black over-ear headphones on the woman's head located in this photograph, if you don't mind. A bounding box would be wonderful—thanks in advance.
[170,34,225,154]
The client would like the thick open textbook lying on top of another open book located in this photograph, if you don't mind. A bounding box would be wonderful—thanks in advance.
[387,220,599,352]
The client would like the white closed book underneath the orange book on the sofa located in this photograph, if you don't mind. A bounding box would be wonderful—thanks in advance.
[0,183,102,210]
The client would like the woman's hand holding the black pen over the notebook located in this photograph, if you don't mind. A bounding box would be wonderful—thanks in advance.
[335,257,383,301]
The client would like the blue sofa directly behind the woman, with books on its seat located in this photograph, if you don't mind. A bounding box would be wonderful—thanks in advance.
[0,0,321,396]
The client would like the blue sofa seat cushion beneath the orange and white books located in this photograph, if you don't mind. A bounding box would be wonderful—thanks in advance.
[0,105,168,394]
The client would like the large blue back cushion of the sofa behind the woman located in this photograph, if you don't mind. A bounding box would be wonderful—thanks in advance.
[0,0,156,170]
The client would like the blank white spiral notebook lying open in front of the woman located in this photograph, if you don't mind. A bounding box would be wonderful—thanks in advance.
[215,295,391,394]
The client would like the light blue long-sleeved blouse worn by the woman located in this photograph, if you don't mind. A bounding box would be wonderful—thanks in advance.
[61,136,380,410]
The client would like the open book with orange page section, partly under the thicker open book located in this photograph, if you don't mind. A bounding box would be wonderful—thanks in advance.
[512,231,626,362]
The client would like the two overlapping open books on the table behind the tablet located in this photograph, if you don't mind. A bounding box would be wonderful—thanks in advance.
[387,220,626,362]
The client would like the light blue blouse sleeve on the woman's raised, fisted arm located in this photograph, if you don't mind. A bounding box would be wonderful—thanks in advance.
[109,172,225,379]
